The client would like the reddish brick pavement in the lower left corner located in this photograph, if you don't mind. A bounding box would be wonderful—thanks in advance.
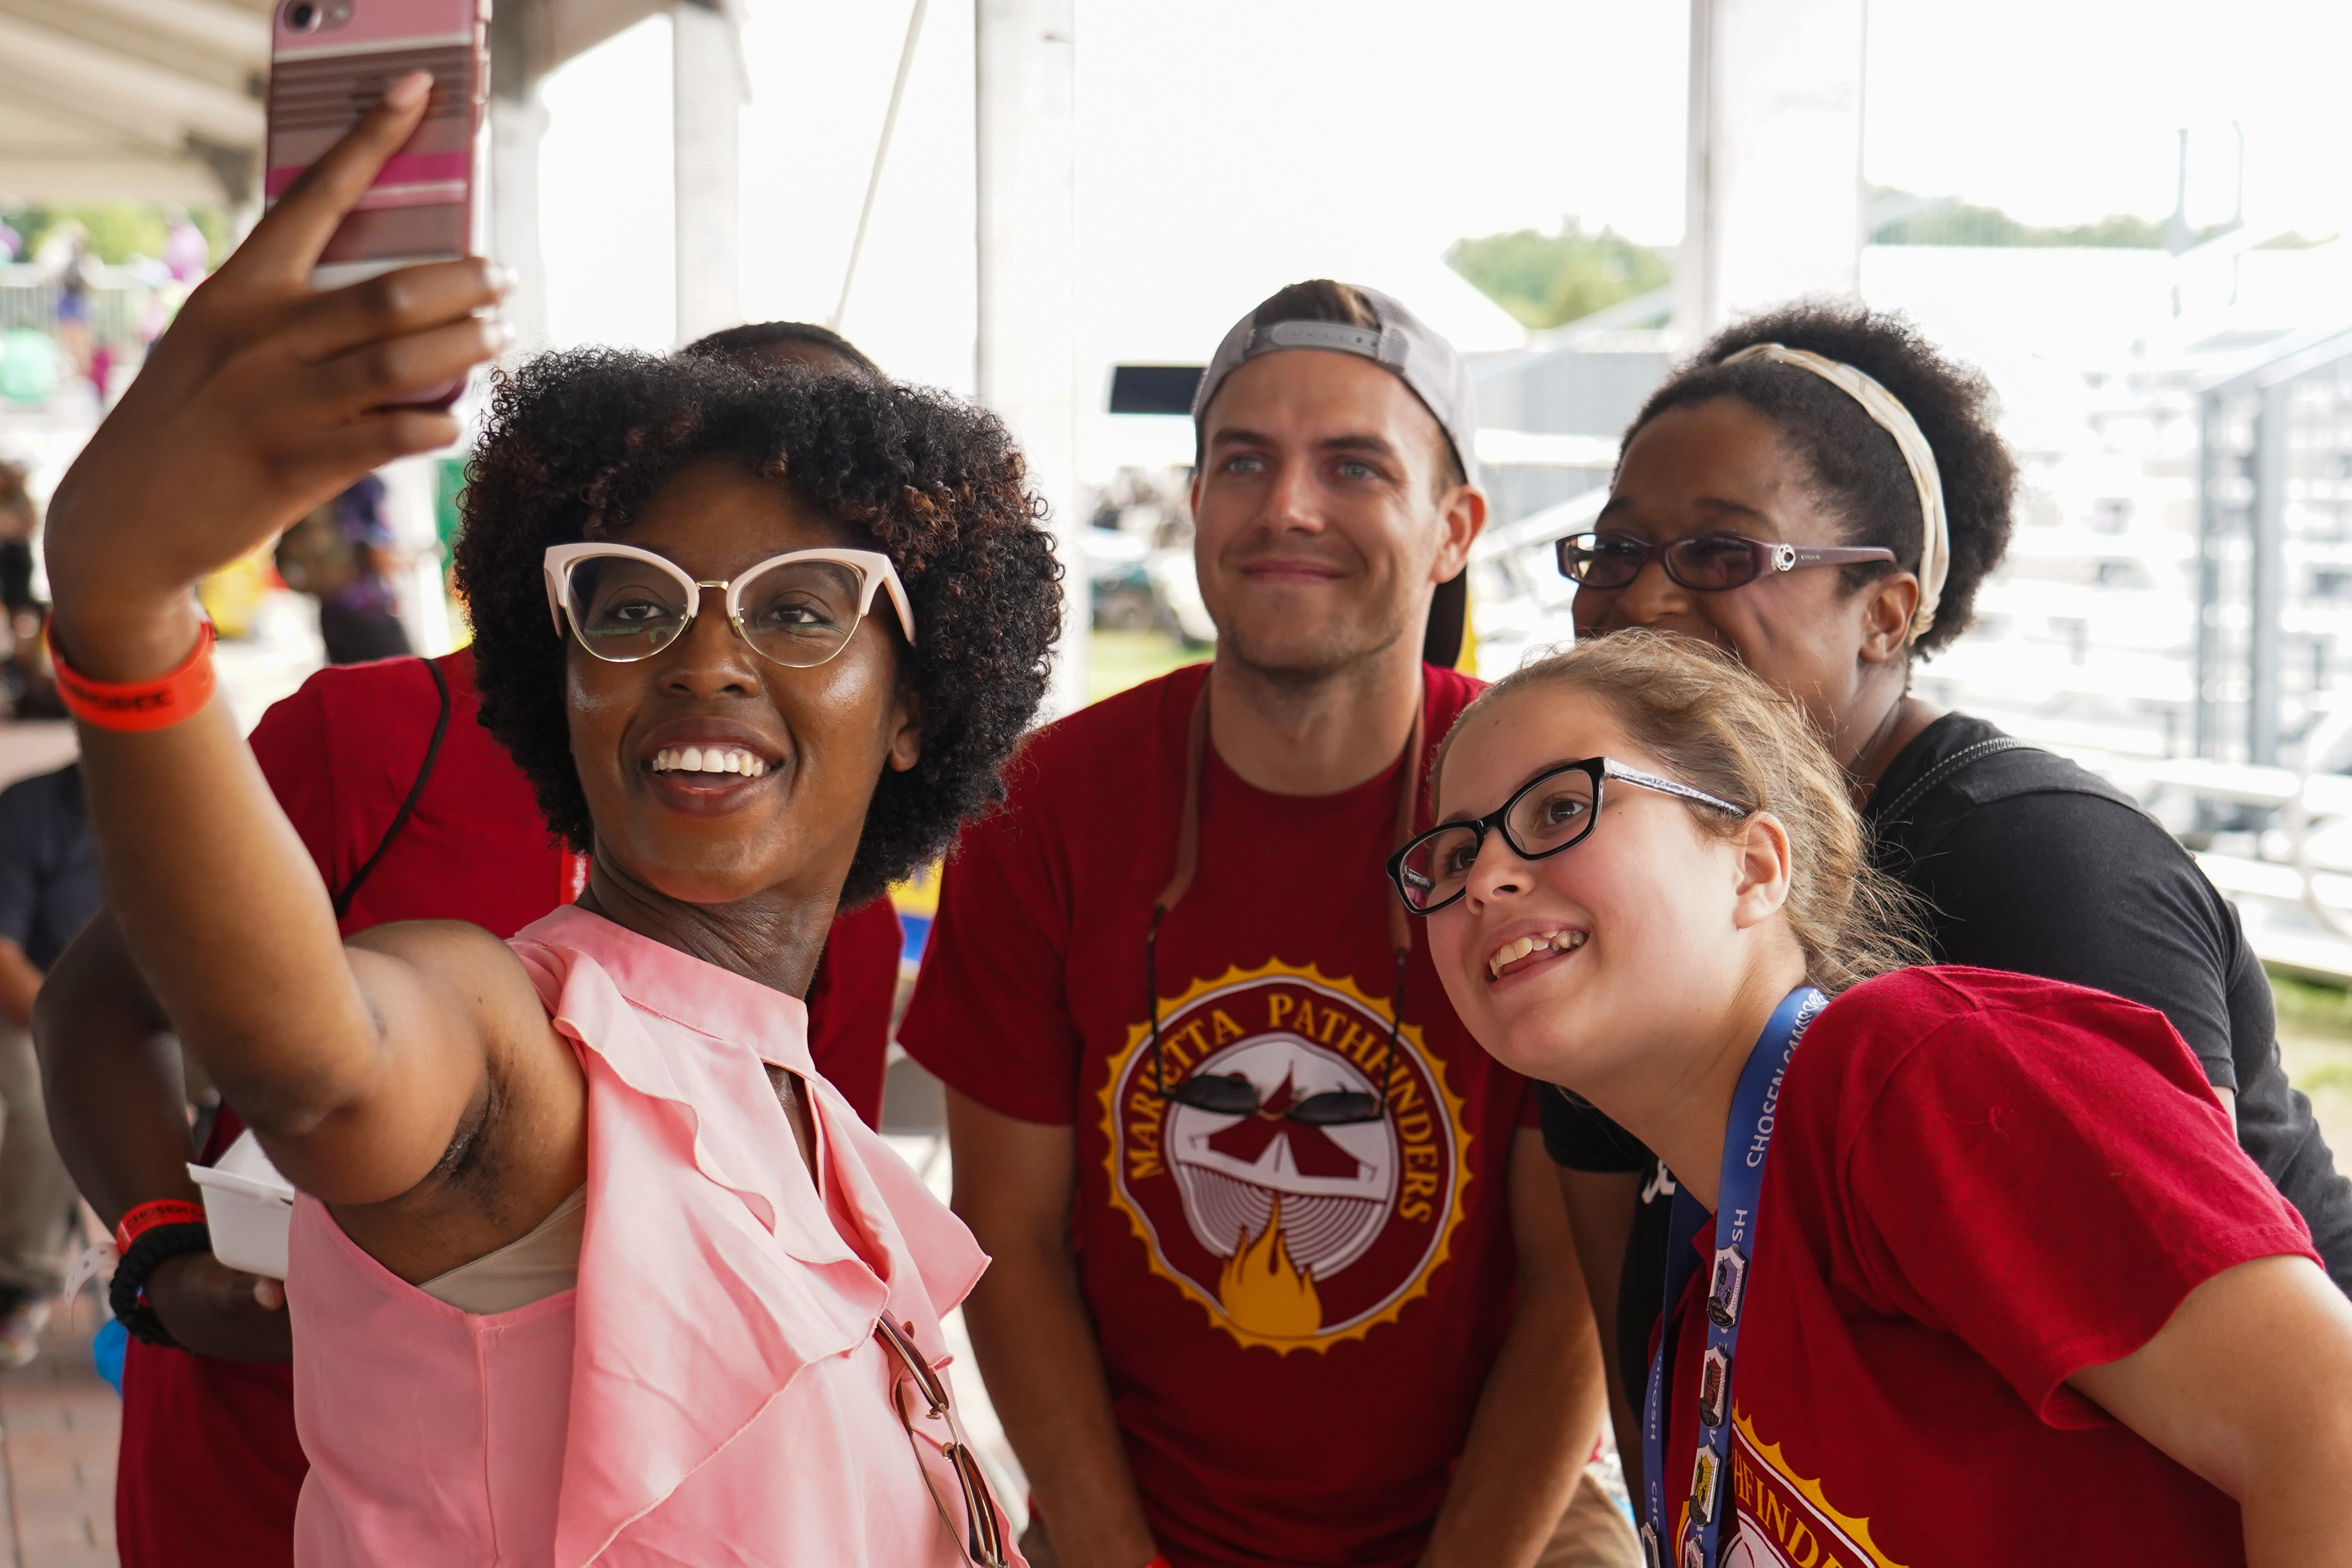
[0,1295,122,1568]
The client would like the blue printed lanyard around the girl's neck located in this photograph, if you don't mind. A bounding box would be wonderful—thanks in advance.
[1642,985,1830,1568]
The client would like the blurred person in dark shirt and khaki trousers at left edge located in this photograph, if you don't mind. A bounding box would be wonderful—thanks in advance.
[0,764,103,1366]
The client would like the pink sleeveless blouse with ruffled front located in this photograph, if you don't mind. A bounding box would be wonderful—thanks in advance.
[287,908,1018,1568]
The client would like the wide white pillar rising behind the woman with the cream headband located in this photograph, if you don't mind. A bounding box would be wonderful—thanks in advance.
[1675,0,1867,341]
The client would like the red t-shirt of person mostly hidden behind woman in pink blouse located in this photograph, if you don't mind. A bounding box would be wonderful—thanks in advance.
[115,649,898,1568]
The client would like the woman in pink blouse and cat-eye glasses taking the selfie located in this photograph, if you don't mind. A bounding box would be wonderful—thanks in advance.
[30,88,1058,1568]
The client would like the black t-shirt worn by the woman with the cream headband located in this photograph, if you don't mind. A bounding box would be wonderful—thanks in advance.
[1543,712,2352,1397]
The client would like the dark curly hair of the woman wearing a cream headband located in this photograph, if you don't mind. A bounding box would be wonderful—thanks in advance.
[1625,301,2018,656]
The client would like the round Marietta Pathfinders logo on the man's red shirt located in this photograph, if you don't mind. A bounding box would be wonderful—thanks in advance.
[1103,964,1470,1352]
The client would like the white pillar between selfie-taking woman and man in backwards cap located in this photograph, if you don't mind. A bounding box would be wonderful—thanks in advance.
[974,0,1091,712]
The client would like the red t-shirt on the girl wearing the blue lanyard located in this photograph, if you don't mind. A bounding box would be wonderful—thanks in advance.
[1665,968,2317,1568]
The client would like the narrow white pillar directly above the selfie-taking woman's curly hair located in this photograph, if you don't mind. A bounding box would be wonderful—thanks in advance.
[670,0,743,343]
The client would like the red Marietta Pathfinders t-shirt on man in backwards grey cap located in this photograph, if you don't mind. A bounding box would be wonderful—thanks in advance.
[898,665,1531,1568]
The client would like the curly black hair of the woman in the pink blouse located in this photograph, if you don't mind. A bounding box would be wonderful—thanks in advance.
[456,348,1061,908]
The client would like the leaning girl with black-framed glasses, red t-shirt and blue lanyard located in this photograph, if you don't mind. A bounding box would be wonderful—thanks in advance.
[1390,632,2352,1568]
